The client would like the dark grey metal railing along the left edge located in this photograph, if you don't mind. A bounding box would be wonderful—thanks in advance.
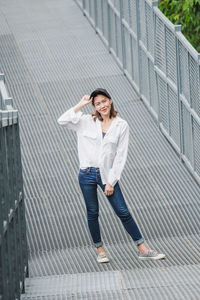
[0,74,28,300]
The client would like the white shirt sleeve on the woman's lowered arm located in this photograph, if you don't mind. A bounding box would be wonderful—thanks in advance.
[108,122,129,187]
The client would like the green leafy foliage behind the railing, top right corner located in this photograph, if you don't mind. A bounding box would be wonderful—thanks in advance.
[158,0,200,52]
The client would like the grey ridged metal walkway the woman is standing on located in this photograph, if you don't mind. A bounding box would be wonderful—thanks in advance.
[0,0,200,300]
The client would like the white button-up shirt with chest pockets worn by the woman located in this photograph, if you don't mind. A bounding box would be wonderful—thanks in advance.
[57,107,129,187]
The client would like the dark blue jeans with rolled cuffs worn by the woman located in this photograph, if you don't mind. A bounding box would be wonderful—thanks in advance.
[78,167,144,247]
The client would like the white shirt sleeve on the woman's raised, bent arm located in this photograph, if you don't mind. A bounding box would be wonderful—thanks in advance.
[57,107,84,131]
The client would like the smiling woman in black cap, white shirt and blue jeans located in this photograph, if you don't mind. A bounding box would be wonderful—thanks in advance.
[58,88,165,263]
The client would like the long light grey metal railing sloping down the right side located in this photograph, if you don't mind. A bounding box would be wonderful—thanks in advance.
[75,0,200,183]
